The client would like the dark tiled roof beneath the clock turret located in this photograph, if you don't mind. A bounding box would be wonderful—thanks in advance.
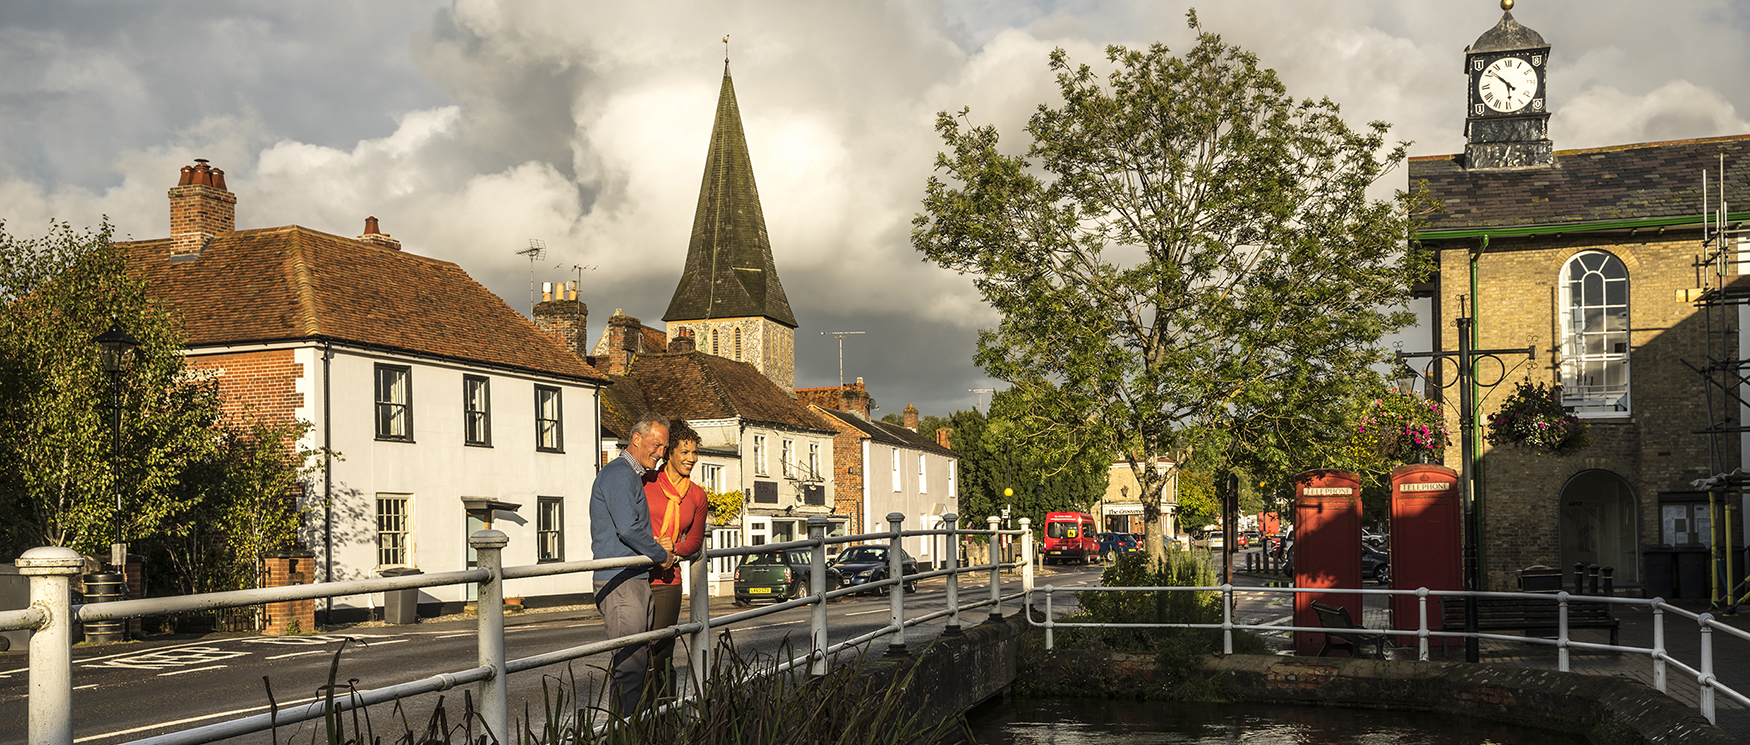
[1409,135,1750,233]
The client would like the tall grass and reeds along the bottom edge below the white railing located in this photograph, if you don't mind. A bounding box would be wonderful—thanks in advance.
[270,633,971,745]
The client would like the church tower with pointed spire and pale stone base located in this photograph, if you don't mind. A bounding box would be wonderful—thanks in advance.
[662,59,796,392]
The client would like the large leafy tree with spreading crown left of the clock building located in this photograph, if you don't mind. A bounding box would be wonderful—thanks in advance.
[912,14,1426,556]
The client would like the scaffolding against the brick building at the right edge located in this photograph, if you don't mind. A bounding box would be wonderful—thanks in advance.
[1661,154,1750,612]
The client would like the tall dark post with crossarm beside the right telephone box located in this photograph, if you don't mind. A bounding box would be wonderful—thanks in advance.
[1397,296,1537,663]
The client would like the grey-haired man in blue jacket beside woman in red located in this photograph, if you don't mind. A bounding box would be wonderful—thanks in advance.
[590,413,676,717]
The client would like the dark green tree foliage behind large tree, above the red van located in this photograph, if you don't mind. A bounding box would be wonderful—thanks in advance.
[945,390,1111,530]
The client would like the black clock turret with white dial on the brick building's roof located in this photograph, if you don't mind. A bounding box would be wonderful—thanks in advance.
[1465,0,1554,170]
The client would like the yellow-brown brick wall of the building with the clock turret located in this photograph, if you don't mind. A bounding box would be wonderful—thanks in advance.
[1426,231,1740,589]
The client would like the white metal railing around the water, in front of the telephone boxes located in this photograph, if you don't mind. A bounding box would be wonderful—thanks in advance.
[1024,584,1750,722]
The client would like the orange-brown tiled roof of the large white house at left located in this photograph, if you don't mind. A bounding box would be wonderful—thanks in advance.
[117,226,607,381]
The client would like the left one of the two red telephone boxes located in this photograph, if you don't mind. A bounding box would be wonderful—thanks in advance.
[1295,469,1362,649]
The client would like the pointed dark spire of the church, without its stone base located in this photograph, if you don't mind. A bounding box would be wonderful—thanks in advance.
[663,62,796,329]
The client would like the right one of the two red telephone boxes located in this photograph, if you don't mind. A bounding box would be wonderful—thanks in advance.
[1391,463,1465,647]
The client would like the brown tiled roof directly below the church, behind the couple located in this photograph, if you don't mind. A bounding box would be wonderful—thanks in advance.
[602,352,833,435]
